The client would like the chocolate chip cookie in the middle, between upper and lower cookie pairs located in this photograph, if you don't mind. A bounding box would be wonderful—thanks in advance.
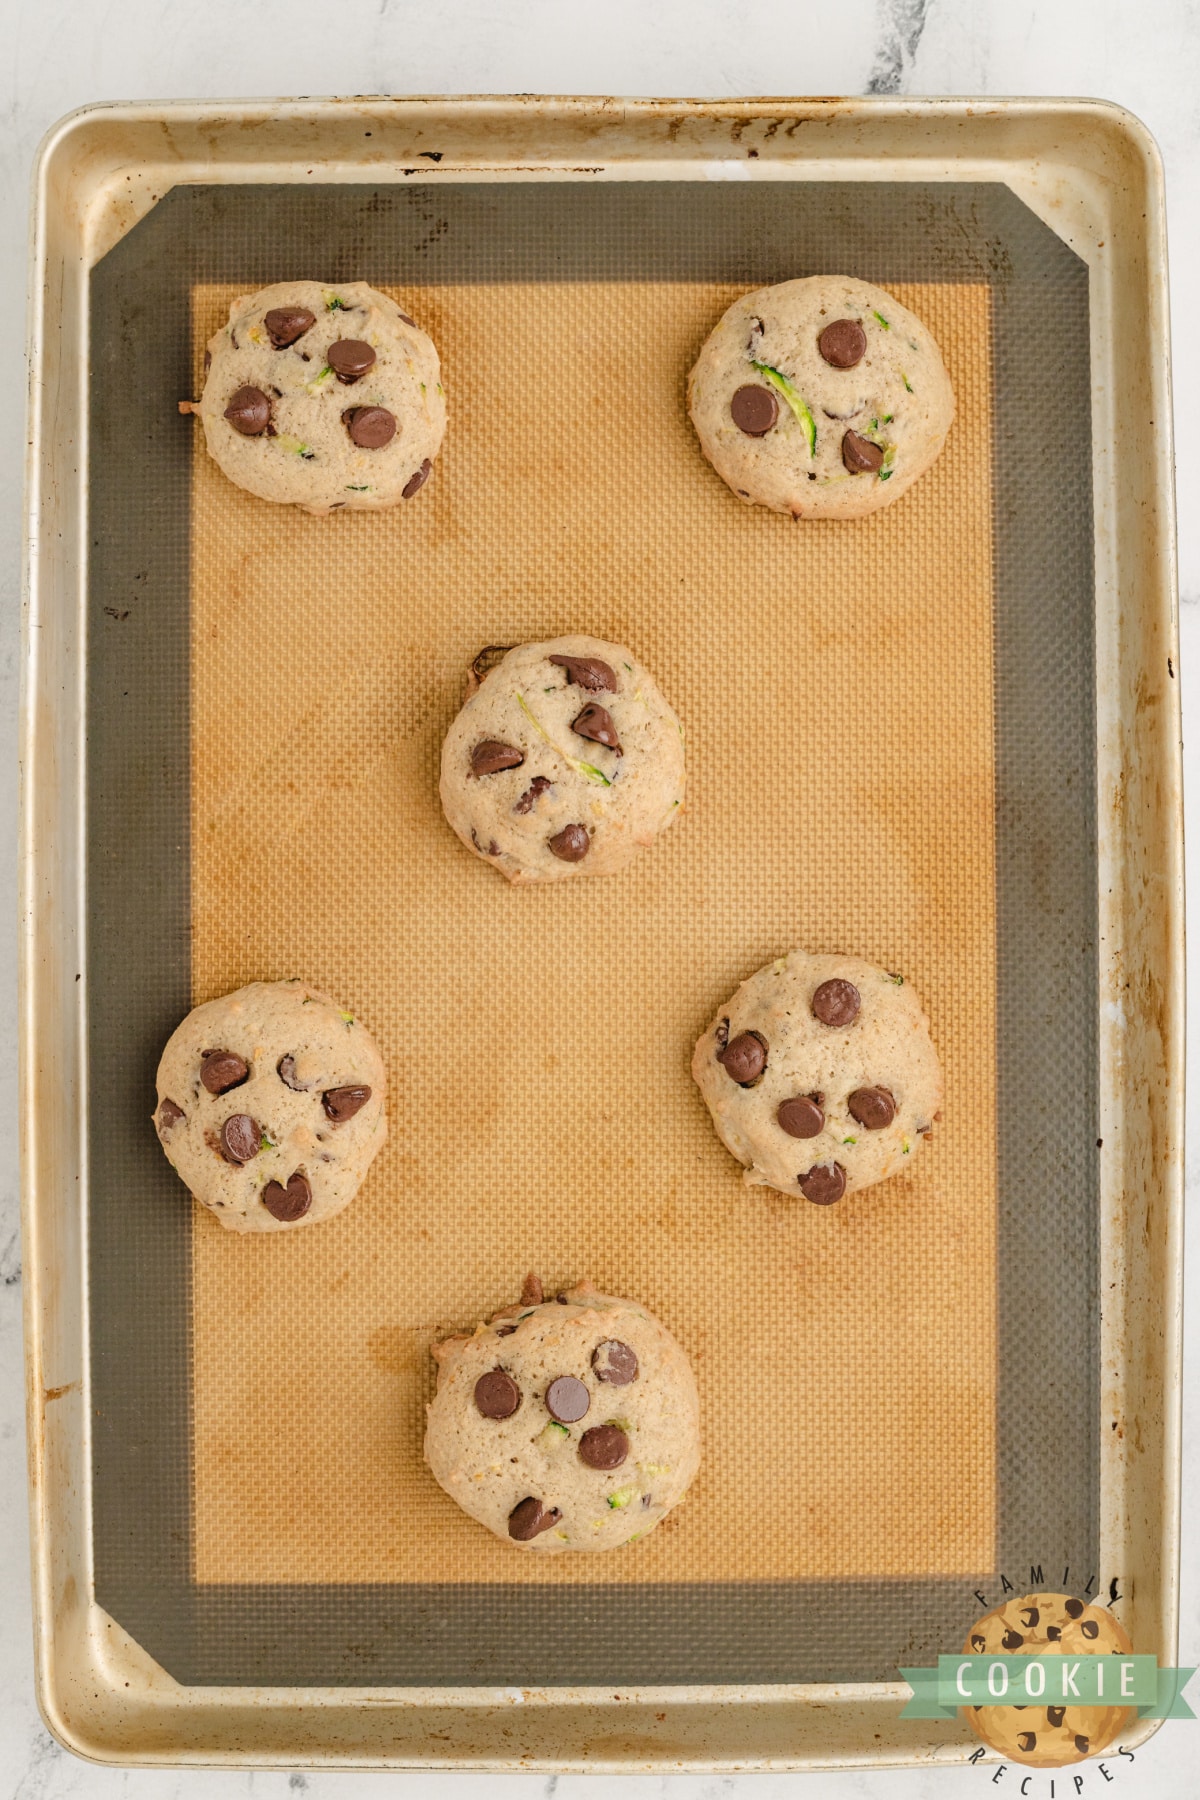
[441,637,684,882]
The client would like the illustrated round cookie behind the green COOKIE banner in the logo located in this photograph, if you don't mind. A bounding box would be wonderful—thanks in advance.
[959,1593,1133,1769]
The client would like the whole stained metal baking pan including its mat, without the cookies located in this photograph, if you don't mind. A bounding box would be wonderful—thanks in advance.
[22,99,1182,1769]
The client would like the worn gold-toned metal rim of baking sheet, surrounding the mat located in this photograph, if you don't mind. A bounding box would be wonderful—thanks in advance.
[20,97,1184,1771]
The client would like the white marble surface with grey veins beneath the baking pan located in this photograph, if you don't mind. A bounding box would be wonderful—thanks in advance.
[0,0,1200,1800]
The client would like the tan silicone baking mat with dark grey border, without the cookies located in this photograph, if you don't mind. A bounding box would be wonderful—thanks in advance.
[92,184,1096,1683]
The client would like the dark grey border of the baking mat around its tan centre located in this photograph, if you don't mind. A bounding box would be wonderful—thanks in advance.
[86,182,1099,1687]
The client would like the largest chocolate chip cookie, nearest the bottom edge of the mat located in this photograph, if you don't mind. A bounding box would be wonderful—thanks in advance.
[425,1276,700,1555]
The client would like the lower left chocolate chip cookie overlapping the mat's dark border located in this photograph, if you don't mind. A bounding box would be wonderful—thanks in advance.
[155,981,387,1231]
